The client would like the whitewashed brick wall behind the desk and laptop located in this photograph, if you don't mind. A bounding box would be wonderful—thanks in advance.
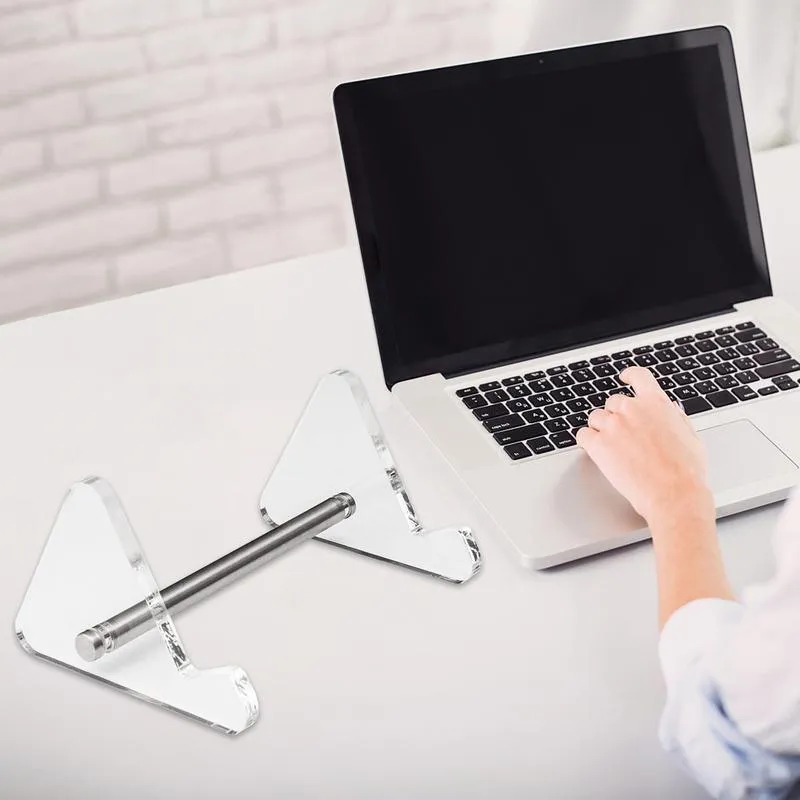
[0,0,500,322]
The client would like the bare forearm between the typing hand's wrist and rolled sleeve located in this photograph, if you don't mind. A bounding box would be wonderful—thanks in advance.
[650,498,734,628]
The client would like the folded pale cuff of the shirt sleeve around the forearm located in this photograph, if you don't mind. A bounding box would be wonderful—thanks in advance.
[658,597,743,691]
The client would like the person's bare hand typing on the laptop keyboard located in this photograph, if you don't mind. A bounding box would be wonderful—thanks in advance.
[577,367,714,529]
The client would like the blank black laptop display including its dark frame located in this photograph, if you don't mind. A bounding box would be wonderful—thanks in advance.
[336,29,770,385]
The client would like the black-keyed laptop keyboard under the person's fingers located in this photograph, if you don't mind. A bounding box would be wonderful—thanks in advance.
[455,322,800,461]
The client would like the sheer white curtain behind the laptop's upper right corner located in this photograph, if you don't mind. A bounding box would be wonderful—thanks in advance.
[493,0,800,150]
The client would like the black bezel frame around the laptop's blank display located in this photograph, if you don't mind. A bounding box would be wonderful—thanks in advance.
[333,26,772,389]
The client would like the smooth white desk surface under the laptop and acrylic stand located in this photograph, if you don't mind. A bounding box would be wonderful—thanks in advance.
[0,147,800,800]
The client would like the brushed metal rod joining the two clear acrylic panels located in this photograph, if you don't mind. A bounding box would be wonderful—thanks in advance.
[75,493,356,661]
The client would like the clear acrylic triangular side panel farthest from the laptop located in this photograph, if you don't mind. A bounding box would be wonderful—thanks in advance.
[16,478,258,734]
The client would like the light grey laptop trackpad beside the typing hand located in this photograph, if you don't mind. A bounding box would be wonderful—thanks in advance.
[699,419,797,496]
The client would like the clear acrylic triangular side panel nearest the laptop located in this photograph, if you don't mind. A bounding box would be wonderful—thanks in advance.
[261,371,481,583]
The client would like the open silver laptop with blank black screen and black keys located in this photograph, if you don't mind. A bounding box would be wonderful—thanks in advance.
[334,27,800,569]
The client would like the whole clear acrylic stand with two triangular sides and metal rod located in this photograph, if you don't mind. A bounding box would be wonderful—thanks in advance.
[16,372,481,734]
